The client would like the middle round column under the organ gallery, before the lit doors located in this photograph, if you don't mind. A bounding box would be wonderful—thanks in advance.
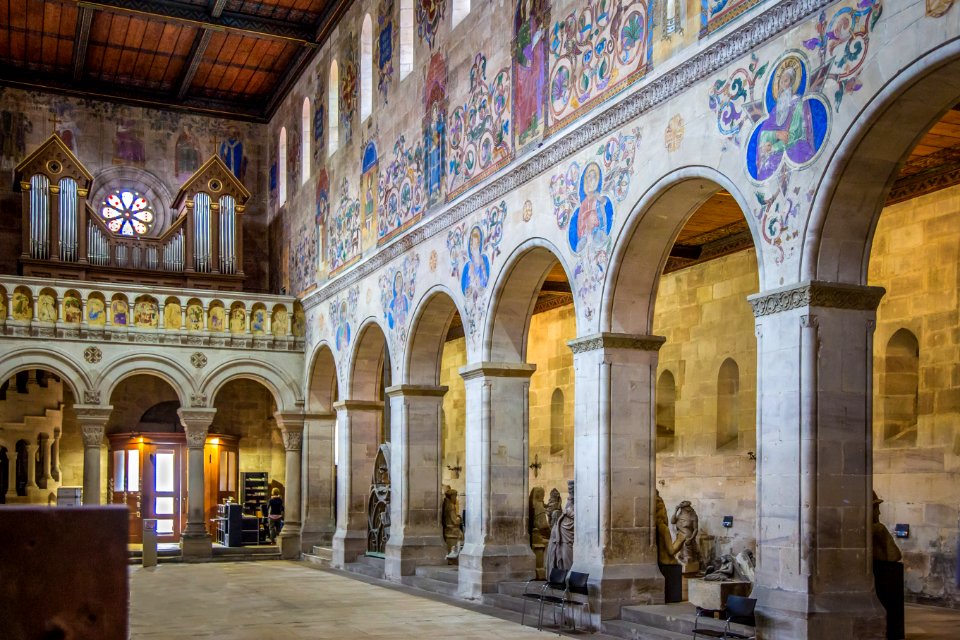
[177,409,217,562]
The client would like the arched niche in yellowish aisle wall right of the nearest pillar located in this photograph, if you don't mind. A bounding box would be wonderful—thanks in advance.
[880,329,920,445]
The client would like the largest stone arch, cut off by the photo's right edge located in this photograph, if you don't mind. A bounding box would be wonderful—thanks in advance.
[800,39,960,284]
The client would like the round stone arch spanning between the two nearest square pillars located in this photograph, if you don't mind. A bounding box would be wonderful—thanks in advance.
[599,166,764,335]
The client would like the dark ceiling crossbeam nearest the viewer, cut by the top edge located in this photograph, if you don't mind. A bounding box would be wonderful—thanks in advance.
[77,0,317,47]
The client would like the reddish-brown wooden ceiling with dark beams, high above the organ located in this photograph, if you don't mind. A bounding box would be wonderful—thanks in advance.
[0,0,350,122]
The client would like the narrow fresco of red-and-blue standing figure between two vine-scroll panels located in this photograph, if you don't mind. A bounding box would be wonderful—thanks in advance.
[423,53,447,207]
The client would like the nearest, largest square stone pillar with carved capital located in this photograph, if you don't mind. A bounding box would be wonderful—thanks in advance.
[750,282,885,639]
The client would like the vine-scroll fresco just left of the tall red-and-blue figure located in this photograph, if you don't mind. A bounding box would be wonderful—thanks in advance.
[377,135,426,244]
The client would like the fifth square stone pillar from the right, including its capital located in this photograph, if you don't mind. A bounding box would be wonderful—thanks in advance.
[331,400,383,569]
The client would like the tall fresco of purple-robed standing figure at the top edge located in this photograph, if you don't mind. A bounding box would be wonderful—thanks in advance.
[513,0,550,149]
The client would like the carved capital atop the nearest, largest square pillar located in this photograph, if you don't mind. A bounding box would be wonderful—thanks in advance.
[747,280,887,318]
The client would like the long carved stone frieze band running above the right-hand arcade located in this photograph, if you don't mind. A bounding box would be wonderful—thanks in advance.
[303,0,834,309]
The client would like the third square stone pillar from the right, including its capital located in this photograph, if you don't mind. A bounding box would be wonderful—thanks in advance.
[459,362,537,599]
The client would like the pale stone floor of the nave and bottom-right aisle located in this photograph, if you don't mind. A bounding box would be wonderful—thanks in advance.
[130,561,960,640]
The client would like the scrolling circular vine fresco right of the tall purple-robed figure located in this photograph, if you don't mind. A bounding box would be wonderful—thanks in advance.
[550,0,653,129]
